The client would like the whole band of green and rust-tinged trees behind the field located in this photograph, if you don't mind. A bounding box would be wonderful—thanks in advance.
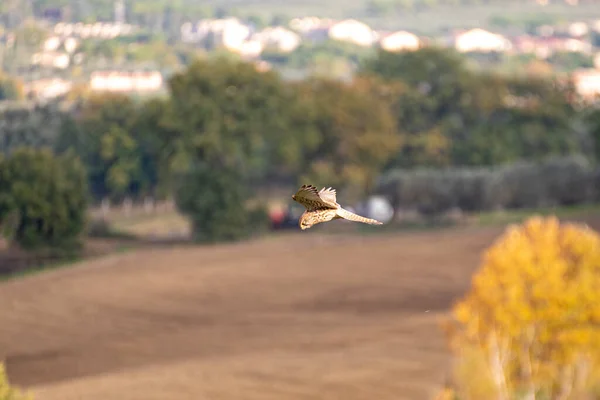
[0,47,600,250]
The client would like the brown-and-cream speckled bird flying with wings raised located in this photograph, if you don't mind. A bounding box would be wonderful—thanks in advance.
[292,185,383,230]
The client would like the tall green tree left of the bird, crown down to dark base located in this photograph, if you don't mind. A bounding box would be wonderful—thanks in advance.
[163,58,293,240]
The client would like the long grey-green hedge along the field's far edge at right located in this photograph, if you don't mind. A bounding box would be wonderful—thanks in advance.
[377,156,598,213]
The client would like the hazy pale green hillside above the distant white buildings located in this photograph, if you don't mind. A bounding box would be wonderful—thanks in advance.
[8,0,600,35]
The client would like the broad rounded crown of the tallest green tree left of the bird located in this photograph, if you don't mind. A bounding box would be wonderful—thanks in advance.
[168,58,294,177]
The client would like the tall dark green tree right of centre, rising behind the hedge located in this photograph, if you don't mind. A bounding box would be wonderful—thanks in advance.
[359,47,474,167]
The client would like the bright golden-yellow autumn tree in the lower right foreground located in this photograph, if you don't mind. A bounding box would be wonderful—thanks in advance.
[447,216,600,400]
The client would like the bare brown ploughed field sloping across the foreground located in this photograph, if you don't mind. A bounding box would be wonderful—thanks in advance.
[0,217,600,400]
